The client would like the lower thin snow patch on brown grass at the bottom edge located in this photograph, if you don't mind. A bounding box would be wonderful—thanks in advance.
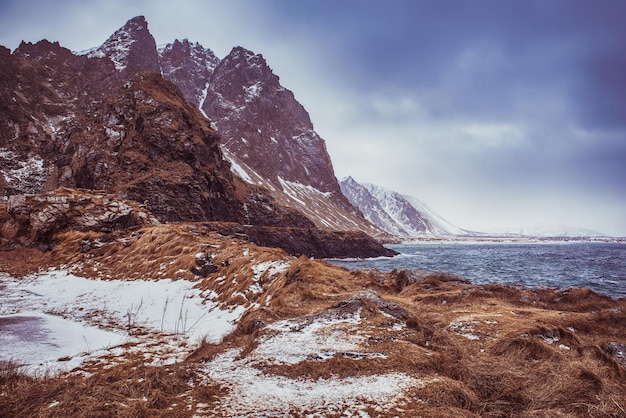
[199,349,416,416]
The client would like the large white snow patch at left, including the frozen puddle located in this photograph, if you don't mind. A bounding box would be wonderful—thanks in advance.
[0,270,245,376]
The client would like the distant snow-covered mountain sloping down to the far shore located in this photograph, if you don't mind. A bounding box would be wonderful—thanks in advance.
[340,177,468,238]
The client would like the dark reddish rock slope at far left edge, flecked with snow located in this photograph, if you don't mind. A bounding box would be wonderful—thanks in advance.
[0,40,122,195]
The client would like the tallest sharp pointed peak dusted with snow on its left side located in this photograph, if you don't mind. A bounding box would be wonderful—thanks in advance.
[88,16,161,76]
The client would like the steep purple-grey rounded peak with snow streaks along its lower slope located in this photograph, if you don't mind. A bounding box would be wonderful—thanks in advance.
[202,47,380,235]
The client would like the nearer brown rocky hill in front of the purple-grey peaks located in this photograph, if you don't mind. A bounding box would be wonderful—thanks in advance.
[50,73,243,221]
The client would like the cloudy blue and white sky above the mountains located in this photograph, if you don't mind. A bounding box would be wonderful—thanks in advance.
[0,0,626,236]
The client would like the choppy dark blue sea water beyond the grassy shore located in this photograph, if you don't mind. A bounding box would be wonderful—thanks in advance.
[329,242,626,298]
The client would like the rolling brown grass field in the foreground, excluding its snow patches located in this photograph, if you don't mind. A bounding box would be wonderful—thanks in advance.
[0,224,626,417]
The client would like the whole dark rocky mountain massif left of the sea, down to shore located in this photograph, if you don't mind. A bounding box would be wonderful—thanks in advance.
[0,17,390,257]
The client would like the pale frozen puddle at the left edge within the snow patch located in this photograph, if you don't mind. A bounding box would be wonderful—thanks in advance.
[0,312,128,372]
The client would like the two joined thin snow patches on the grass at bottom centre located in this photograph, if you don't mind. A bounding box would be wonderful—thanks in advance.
[199,312,425,416]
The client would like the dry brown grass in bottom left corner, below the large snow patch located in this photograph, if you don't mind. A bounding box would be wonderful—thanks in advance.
[0,361,224,418]
